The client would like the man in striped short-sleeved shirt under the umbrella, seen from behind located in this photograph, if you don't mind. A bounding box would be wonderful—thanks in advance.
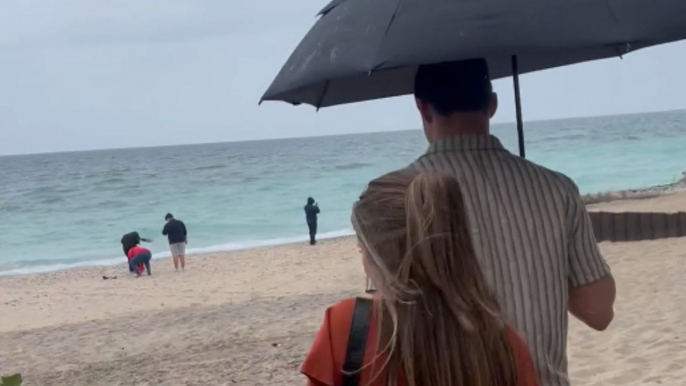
[382,60,615,386]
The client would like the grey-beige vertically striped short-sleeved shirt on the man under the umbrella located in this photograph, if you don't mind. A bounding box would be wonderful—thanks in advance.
[411,135,610,386]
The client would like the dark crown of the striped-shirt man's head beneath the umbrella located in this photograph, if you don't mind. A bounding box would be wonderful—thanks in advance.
[414,59,493,116]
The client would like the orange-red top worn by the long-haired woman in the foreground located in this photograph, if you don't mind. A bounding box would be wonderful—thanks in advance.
[301,299,538,386]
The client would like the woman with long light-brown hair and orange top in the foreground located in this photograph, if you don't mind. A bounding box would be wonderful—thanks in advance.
[302,171,536,386]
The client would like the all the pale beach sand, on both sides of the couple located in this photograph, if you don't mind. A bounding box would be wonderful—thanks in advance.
[0,195,686,386]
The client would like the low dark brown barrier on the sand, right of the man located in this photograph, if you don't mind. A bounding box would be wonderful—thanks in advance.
[589,212,686,242]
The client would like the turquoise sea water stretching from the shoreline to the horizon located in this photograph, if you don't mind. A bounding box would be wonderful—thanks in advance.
[0,111,686,275]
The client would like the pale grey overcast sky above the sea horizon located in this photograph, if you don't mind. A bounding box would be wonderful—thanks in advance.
[0,0,686,154]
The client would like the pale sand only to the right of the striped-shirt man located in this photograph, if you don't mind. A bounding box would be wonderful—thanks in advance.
[569,194,686,386]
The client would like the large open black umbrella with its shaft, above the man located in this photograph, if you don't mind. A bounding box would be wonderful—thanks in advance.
[262,0,686,156]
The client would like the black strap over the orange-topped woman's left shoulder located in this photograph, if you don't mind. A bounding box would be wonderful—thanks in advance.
[343,298,372,386]
